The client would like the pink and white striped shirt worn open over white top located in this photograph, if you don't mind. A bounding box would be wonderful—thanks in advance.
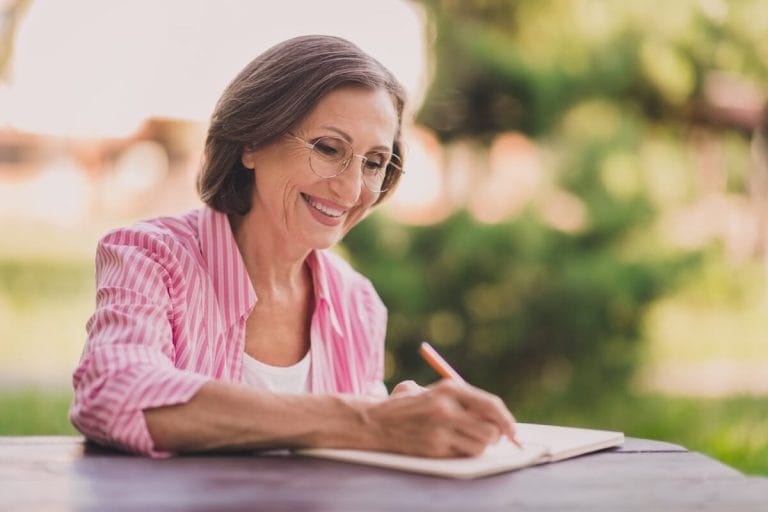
[70,207,387,457]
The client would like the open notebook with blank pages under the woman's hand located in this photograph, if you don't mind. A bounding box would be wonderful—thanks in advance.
[296,423,624,478]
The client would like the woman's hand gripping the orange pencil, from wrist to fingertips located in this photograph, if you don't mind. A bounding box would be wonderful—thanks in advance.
[368,379,515,457]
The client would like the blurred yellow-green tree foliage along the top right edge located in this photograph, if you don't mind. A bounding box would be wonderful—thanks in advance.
[418,0,768,140]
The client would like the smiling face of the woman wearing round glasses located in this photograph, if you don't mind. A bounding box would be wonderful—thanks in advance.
[242,87,398,250]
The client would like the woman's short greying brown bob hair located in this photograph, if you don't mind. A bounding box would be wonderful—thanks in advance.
[197,35,405,215]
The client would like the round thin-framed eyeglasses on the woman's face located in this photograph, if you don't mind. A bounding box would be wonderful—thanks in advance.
[288,133,404,194]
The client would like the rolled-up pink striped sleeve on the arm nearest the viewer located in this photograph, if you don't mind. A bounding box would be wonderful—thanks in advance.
[70,230,210,457]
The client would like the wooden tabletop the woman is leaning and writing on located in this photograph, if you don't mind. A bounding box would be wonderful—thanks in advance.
[0,437,768,512]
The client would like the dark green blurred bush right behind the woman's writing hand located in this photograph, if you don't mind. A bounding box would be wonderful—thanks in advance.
[345,205,688,404]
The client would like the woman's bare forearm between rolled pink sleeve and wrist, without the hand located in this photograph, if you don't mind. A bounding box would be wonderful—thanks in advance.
[144,381,378,453]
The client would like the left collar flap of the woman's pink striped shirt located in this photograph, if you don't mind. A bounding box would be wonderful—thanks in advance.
[198,206,256,326]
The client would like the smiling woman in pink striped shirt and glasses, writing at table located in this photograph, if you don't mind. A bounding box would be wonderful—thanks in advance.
[70,36,514,457]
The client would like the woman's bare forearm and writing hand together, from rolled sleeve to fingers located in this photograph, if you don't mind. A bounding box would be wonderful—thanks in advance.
[144,380,514,457]
